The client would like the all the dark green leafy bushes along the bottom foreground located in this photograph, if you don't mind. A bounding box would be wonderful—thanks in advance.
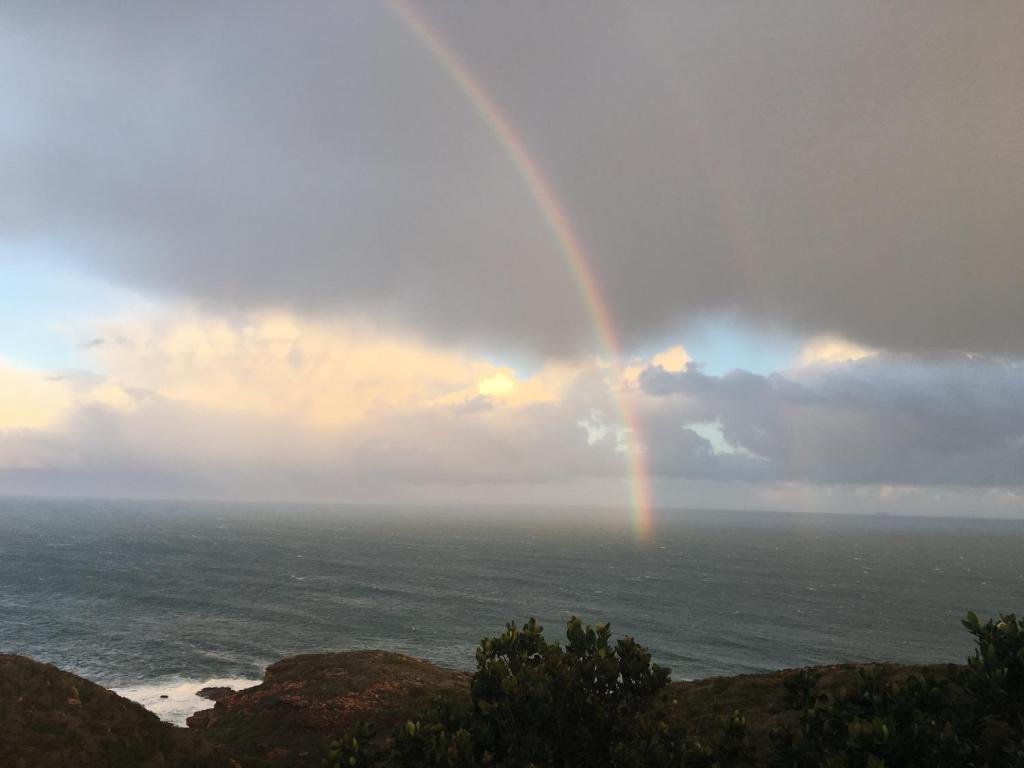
[324,613,1024,768]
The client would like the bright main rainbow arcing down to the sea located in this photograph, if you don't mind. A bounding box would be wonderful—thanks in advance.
[388,0,651,540]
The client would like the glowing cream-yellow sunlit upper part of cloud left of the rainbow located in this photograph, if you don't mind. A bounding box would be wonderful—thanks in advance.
[83,306,579,427]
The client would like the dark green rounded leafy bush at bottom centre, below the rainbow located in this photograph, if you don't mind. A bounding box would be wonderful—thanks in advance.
[324,616,750,768]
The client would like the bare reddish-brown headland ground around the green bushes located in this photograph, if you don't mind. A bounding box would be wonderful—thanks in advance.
[0,650,946,768]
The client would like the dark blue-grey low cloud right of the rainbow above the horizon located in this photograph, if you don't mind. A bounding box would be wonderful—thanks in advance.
[641,356,1024,486]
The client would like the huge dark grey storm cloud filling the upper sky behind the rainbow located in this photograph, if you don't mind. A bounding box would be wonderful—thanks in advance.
[0,0,1024,354]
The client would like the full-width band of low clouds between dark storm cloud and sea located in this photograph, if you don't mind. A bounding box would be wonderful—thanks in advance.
[0,306,1024,507]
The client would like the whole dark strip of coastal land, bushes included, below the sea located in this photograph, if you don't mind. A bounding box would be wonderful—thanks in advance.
[0,614,1024,768]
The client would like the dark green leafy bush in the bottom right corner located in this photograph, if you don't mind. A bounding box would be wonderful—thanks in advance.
[768,613,1024,768]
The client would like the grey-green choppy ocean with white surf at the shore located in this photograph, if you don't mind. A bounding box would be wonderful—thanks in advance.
[0,498,1024,723]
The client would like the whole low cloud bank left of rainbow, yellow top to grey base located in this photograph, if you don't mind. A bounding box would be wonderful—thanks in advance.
[0,307,626,499]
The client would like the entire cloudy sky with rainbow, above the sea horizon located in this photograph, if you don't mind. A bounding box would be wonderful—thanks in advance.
[0,0,1024,517]
